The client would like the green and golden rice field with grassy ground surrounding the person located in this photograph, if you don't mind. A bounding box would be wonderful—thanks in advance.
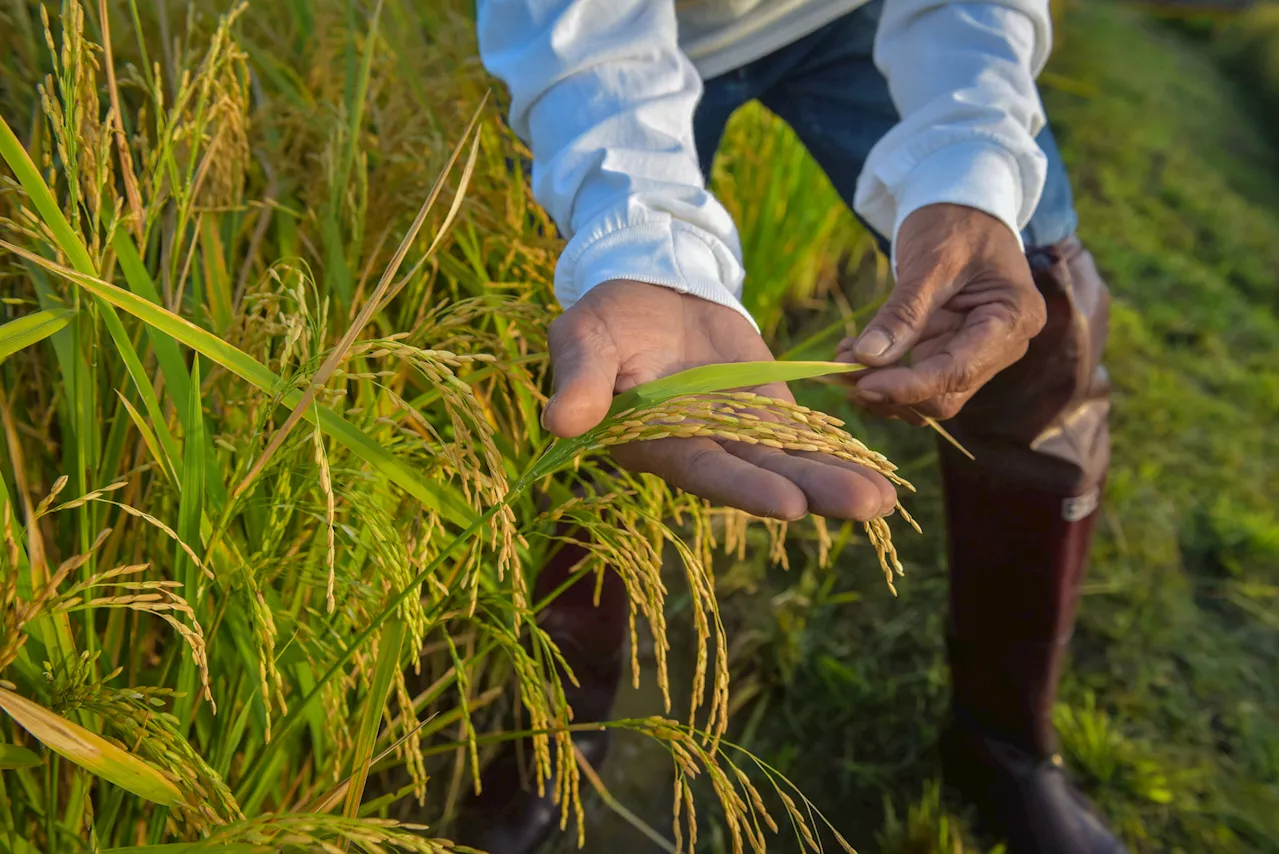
[0,0,1280,854]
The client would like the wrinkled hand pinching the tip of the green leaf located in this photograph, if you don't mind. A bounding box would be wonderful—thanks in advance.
[836,205,1044,421]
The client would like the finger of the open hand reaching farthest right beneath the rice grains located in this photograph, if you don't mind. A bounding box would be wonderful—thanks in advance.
[724,442,896,522]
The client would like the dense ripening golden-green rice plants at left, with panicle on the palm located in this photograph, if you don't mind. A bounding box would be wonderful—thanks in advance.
[0,0,909,854]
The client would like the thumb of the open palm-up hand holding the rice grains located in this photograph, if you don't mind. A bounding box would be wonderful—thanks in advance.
[543,309,618,438]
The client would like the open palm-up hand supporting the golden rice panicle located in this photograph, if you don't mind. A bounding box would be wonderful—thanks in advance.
[543,279,896,521]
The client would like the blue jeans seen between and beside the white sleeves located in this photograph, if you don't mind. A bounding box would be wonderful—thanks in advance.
[694,0,1076,248]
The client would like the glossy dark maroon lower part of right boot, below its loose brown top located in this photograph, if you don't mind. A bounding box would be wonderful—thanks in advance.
[943,450,1125,854]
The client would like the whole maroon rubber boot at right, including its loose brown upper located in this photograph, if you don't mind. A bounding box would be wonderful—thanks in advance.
[942,238,1125,854]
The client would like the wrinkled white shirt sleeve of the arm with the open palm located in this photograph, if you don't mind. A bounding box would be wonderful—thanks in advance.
[477,0,754,325]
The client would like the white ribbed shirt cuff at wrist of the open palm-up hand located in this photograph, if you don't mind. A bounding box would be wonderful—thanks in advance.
[556,215,759,330]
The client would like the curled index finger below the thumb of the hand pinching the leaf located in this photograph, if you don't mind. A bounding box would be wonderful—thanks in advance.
[858,311,1027,405]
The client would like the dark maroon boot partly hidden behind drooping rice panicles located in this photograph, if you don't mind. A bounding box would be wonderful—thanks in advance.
[454,530,627,854]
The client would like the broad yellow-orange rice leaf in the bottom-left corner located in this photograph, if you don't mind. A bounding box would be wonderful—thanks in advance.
[0,688,182,807]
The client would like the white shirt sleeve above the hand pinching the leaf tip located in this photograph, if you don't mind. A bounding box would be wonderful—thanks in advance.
[854,0,1052,257]
